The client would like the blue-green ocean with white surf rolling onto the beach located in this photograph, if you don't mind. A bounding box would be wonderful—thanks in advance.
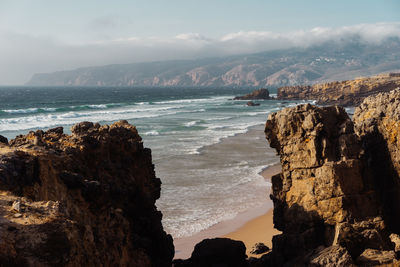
[0,87,308,238]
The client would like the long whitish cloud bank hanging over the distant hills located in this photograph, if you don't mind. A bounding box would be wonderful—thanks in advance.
[0,22,400,84]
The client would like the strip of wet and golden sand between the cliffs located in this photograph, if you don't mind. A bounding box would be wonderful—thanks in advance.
[174,164,281,259]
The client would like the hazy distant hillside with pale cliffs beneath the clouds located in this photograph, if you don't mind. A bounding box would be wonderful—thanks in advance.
[27,38,400,87]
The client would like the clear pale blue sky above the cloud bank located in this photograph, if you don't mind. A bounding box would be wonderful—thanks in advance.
[0,0,400,43]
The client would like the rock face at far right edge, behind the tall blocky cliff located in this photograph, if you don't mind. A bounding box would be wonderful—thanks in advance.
[354,89,400,234]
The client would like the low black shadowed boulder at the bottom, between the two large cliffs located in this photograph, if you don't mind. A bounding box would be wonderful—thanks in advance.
[174,238,247,267]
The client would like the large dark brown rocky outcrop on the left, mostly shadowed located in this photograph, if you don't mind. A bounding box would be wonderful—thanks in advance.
[0,121,174,266]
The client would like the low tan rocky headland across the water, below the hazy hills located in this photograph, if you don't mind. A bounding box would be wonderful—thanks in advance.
[277,73,400,106]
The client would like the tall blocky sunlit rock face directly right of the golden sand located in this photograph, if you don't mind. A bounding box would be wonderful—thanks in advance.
[265,104,400,266]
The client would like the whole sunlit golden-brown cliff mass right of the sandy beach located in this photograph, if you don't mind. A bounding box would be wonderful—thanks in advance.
[260,90,400,266]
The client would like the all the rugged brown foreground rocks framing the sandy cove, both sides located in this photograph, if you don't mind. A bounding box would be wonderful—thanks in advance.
[0,89,400,266]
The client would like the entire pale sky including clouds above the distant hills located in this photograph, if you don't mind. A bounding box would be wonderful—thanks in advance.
[0,0,400,85]
